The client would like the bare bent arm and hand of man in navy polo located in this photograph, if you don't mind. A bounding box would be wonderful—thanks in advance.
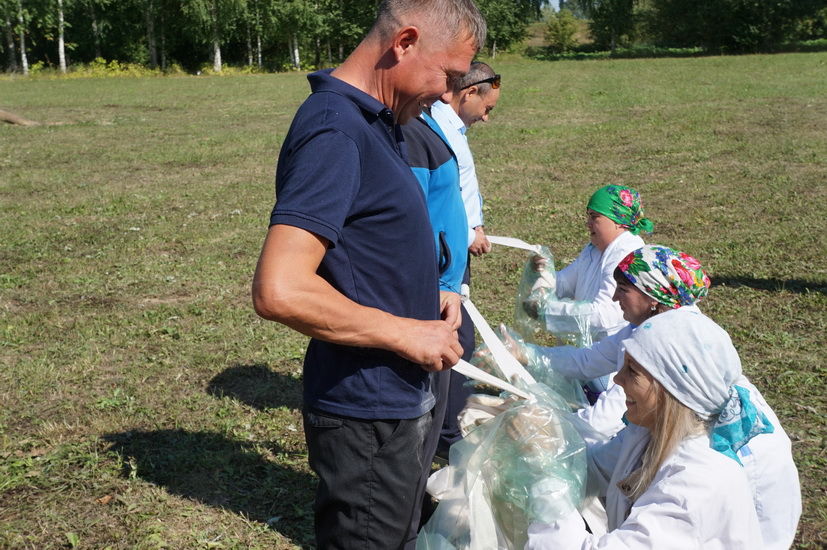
[252,225,462,371]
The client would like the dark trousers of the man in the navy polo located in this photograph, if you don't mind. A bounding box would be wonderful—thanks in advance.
[304,411,433,550]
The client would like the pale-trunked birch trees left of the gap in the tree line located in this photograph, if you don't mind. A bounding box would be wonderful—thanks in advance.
[0,0,544,74]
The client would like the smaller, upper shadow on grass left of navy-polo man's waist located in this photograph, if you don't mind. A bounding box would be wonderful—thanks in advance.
[207,364,302,410]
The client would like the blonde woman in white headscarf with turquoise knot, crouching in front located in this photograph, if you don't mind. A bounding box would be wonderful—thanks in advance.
[526,308,796,550]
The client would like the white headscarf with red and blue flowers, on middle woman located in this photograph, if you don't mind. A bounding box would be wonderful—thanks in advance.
[617,244,711,309]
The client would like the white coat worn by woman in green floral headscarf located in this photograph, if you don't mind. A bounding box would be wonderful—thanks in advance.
[555,231,645,341]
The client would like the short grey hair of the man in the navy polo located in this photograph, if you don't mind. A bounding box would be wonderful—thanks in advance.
[371,0,487,49]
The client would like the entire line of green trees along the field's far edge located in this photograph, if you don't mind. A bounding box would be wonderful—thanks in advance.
[0,0,827,74]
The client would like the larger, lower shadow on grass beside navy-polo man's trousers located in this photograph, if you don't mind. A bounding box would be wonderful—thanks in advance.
[104,430,316,547]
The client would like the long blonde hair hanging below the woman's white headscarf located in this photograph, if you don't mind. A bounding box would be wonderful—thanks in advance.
[617,380,708,502]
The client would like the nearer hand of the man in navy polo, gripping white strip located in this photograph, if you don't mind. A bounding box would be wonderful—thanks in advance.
[394,318,462,372]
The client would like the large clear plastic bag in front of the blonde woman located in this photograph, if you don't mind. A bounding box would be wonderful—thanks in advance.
[417,384,586,550]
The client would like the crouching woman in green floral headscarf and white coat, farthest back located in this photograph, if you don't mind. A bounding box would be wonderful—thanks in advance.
[525,185,654,340]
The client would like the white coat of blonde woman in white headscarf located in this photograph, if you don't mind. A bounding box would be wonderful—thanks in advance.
[526,425,763,550]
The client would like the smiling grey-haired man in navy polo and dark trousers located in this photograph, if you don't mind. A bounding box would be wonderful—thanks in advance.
[253,0,485,549]
